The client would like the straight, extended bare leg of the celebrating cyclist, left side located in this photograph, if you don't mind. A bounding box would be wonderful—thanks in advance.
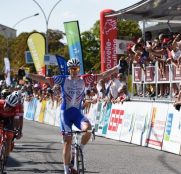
[63,135,72,165]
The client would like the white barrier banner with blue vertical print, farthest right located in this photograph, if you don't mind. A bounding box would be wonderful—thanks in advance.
[162,104,181,154]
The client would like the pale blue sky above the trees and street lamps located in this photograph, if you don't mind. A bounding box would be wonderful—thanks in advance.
[0,0,140,35]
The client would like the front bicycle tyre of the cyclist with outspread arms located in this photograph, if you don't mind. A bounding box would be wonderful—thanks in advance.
[76,146,84,174]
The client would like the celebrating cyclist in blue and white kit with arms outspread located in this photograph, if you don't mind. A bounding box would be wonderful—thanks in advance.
[27,58,119,174]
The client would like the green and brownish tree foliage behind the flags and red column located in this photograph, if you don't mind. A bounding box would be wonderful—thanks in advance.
[0,20,141,75]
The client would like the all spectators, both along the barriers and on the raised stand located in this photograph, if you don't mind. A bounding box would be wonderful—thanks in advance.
[0,33,181,109]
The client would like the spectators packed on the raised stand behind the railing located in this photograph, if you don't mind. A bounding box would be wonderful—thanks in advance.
[127,32,181,97]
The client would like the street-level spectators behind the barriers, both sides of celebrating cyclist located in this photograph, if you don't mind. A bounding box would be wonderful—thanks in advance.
[0,66,129,111]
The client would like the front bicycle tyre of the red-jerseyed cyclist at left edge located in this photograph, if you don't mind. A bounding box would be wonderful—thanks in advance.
[0,143,7,174]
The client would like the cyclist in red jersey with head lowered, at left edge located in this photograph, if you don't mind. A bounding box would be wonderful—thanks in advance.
[0,92,23,156]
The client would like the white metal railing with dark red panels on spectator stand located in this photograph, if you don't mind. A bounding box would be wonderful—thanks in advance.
[131,62,181,102]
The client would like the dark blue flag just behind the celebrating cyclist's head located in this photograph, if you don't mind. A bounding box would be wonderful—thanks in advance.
[55,55,68,75]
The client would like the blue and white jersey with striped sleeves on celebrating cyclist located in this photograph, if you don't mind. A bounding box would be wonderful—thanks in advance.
[53,74,97,110]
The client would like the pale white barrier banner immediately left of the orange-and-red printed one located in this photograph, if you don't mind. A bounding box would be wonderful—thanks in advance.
[129,102,152,146]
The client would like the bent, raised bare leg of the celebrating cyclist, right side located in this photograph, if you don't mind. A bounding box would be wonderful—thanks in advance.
[81,122,91,145]
